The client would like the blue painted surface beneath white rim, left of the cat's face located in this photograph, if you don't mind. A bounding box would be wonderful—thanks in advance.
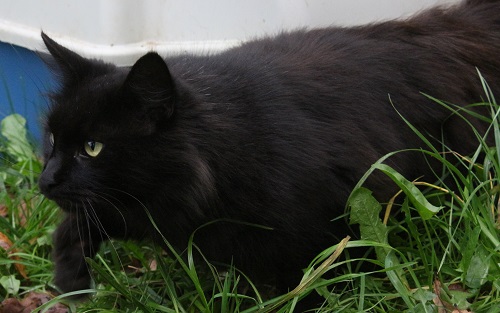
[0,42,55,141]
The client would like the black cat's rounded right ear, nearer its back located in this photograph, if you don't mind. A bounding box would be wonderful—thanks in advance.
[123,52,176,119]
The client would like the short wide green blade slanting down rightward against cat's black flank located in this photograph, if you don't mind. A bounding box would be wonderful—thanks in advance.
[373,164,441,220]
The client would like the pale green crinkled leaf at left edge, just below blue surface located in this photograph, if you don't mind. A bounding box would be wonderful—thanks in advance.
[0,114,35,162]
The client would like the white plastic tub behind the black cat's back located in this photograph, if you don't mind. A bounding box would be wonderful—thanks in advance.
[0,0,457,65]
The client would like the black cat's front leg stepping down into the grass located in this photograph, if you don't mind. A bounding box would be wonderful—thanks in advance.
[53,214,102,292]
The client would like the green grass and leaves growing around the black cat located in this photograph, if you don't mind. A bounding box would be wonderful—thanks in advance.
[0,84,500,313]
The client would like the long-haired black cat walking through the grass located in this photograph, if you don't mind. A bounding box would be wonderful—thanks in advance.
[39,0,500,298]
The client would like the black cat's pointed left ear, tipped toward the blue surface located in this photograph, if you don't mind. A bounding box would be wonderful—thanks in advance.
[42,32,90,83]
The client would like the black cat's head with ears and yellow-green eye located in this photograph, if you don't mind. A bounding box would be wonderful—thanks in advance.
[39,33,182,209]
